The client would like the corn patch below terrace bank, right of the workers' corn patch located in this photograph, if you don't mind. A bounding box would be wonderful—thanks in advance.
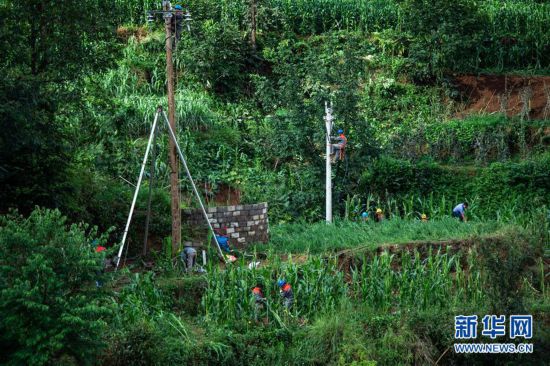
[350,251,484,311]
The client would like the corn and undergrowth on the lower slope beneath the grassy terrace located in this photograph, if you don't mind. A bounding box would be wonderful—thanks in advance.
[100,221,549,365]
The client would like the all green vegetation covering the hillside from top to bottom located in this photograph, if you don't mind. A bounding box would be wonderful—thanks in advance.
[0,0,550,365]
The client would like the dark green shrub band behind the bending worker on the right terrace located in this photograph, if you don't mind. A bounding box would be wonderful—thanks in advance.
[361,154,550,218]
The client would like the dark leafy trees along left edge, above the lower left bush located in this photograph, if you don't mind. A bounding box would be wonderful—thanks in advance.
[0,0,116,212]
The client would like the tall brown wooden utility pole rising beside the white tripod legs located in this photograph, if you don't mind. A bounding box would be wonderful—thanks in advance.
[162,1,181,255]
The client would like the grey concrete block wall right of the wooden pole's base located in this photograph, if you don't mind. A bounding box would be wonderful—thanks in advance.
[182,202,269,248]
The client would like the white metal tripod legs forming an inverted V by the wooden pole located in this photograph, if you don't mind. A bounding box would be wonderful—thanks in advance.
[115,106,226,269]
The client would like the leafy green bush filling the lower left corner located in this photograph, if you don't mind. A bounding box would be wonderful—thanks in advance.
[0,209,110,365]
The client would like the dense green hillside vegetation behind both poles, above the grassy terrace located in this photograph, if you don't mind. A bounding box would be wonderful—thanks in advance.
[0,0,550,226]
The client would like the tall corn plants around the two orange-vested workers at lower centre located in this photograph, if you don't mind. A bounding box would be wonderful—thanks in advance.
[202,256,346,322]
